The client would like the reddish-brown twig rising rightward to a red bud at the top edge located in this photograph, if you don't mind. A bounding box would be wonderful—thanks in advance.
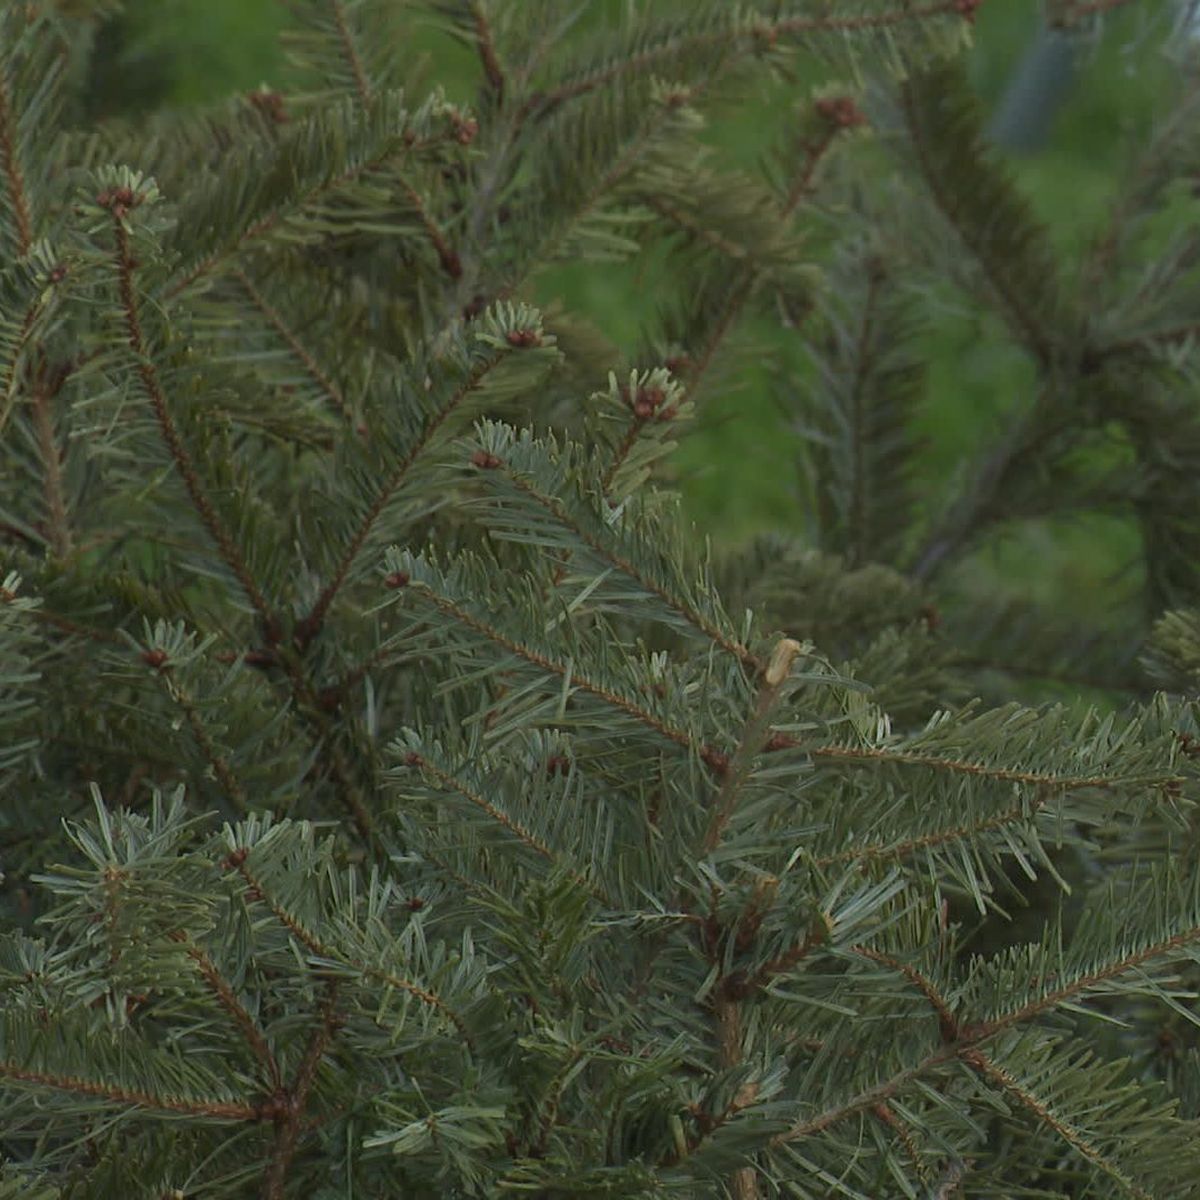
[526,0,983,116]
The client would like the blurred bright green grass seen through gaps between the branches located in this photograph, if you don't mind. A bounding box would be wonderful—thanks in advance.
[91,0,1177,614]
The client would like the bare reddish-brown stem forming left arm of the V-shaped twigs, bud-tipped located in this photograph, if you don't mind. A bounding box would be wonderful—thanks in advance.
[104,188,272,623]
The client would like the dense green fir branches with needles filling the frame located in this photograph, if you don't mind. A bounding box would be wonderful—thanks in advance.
[0,0,1200,1200]
